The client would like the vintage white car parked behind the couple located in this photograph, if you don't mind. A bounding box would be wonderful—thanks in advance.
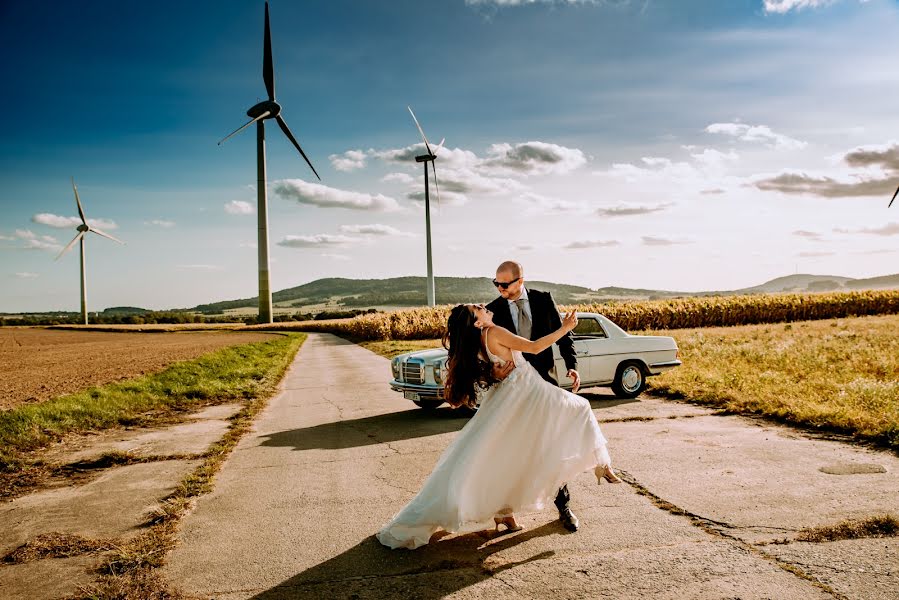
[390,312,681,409]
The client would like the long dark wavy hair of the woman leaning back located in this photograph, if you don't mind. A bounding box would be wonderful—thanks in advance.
[443,304,498,408]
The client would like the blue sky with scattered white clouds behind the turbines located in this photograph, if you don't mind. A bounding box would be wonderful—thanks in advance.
[0,0,899,311]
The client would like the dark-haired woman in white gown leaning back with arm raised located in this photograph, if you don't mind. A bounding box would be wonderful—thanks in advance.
[377,304,621,548]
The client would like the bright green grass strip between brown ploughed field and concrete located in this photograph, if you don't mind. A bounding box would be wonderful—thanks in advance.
[0,334,306,472]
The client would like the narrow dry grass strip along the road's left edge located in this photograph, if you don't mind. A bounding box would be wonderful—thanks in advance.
[75,334,306,600]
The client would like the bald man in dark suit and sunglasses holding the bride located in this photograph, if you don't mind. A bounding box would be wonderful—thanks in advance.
[487,261,581,531]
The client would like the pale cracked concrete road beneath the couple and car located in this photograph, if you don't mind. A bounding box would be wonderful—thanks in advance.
[166,334,899,600]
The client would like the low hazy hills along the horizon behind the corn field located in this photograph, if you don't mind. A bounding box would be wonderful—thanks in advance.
[190,274,899,314]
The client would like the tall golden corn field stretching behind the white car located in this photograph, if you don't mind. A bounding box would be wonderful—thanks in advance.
[264,290,899,341]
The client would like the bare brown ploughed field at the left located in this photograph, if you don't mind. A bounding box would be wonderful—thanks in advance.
[0,328,275,410]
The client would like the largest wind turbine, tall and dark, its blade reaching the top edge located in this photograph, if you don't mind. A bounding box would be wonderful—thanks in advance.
[219,2,321,323]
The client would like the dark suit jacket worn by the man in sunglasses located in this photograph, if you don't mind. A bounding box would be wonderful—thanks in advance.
[487,288,577,381]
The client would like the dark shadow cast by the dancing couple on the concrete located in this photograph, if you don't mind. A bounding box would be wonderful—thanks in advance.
[254,521,567,600]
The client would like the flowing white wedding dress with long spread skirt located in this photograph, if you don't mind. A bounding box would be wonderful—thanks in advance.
[377,330,611,548]
